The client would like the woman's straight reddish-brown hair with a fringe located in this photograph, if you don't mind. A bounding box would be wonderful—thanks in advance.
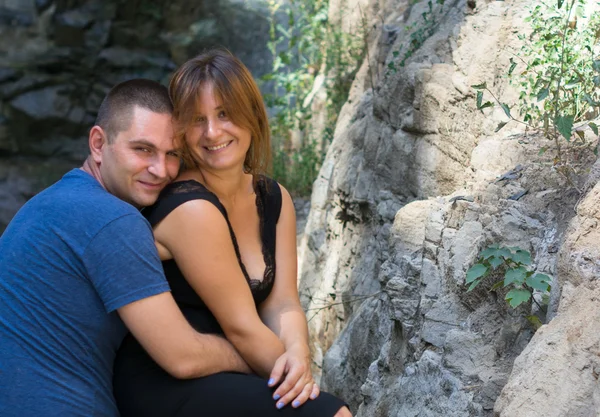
[169,49,271,175]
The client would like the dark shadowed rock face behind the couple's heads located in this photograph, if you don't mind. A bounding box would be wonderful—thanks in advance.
[0,0,271,232]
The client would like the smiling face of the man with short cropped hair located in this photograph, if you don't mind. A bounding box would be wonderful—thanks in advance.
[100,106,179,208]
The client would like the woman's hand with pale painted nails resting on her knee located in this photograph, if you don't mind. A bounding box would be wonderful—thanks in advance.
[269,346,320,408]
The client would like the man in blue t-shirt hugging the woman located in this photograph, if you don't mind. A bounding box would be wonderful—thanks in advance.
[0,80,250,417]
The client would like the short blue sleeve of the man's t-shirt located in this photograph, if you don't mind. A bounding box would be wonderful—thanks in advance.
[83,213,169,313]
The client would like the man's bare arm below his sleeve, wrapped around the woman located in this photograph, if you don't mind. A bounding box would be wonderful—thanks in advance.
[118,292,252,379]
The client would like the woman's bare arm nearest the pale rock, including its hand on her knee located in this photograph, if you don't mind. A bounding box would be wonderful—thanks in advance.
[260,187,319,405]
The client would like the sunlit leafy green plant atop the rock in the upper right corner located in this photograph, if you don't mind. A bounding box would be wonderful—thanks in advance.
[472,0,600,175]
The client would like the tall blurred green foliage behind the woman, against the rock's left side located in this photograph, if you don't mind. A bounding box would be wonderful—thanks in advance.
[262,0,364,195]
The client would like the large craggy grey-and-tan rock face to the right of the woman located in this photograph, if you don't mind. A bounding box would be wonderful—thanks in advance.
[299,0,598,417]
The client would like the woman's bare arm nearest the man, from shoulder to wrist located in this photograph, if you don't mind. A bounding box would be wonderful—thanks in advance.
[154,200,284,376]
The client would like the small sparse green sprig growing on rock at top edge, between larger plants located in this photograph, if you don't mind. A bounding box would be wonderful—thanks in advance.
[387,0,445,73]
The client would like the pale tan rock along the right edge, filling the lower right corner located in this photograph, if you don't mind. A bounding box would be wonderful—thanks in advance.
[494,158,600,417]
